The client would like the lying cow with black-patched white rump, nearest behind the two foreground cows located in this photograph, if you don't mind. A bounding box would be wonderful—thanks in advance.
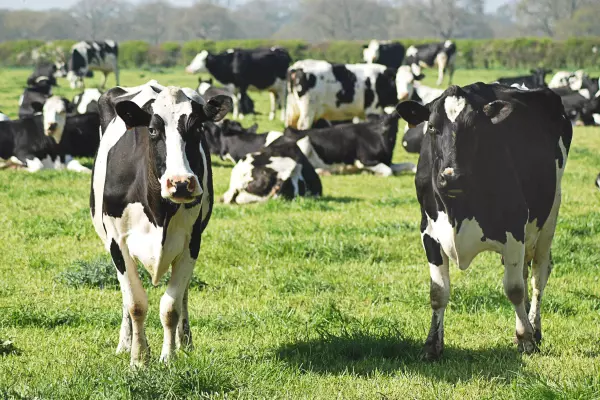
[223,137,323,204]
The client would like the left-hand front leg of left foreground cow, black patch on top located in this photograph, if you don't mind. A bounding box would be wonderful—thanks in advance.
[110,240,150,366]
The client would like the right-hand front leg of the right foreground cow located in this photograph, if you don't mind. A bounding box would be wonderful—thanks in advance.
[502,235,537,354]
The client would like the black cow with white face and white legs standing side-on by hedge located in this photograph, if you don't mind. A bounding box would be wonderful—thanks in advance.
[185,47,292,120]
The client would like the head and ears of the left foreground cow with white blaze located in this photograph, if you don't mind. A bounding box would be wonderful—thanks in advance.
[115,87,232,203]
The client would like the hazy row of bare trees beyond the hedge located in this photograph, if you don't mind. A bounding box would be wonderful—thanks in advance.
[0,0,600,44]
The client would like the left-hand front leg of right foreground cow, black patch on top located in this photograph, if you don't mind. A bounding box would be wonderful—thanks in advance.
[422,233,450,361]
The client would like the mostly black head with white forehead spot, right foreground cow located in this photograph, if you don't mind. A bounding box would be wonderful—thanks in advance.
[397,86,513,197]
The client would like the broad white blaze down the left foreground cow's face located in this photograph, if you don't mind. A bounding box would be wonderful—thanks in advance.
[151,86,202,199]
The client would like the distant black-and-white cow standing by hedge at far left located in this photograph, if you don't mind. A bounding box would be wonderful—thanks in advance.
[67,40,119,89]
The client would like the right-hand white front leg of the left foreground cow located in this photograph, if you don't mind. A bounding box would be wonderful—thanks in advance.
[160,251,196,362]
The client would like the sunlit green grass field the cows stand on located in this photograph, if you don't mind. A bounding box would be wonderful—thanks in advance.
[0,70,600,399]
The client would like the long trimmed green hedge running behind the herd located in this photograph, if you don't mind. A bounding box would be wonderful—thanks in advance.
[0,37,600,69]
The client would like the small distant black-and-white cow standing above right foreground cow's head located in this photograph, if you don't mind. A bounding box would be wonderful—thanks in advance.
[404,40,456,86]
